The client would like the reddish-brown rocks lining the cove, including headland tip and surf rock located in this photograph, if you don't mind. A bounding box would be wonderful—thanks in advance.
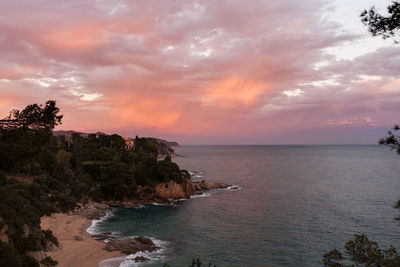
[39,179,232,266]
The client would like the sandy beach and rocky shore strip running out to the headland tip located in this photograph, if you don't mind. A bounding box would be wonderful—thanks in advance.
[40,180,231,267]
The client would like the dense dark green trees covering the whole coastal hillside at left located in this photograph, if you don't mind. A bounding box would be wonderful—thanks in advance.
[0,101,190,266]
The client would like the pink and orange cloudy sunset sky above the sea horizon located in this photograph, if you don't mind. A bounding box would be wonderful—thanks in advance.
[0,0,400,144]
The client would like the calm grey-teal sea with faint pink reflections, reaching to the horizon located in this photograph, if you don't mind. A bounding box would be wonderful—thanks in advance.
[94,145,400,267]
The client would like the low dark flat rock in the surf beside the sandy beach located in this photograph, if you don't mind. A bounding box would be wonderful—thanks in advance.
[105,237,160,254]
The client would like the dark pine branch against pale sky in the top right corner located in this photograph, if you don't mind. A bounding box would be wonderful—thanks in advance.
[360,1,400,43]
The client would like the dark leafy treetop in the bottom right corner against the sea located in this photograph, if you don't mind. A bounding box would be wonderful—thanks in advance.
[322,234,400,267]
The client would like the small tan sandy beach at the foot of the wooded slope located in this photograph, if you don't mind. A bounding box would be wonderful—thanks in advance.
[40,213,123,267]
